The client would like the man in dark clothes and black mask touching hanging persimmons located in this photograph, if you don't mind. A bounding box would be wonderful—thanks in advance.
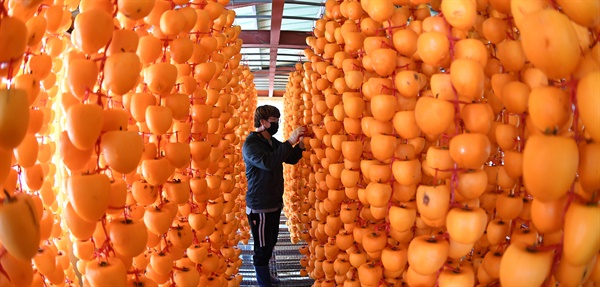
[242,105,305,287]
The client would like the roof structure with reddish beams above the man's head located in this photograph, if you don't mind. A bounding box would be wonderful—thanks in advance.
[227,0,325,97]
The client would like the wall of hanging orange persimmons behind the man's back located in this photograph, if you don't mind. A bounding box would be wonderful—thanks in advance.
[0,0,256,286]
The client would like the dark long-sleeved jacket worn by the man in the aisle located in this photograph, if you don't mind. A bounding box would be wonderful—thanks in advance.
[242,132,302,210]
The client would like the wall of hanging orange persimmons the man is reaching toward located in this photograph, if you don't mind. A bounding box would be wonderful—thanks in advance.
[286,0,600,286]
